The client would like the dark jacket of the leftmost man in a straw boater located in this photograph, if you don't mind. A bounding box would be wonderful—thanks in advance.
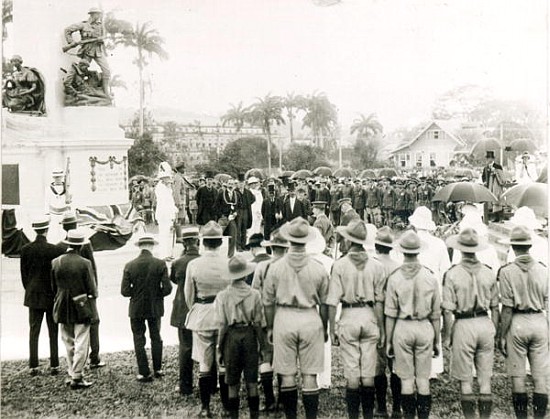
[20,235,63,310]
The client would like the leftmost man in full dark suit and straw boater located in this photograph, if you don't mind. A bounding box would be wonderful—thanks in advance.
[20,217,63,376]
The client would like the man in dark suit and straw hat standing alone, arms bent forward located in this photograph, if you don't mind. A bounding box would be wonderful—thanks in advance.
[121,234,172,382]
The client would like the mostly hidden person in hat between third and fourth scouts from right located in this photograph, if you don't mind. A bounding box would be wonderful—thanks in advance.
[374,226,402,419]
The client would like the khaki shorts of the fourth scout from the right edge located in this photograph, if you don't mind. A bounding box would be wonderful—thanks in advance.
[338,307,380,380]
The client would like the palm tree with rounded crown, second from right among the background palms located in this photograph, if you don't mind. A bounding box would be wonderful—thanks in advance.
[302,92,338,146]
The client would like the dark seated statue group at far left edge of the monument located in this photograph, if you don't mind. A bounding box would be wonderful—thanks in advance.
[2,55,46,114]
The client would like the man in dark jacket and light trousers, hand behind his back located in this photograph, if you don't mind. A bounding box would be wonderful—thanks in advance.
[52,229,97,390]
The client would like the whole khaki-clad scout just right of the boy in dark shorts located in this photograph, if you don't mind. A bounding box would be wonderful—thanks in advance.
[263,217,329,418]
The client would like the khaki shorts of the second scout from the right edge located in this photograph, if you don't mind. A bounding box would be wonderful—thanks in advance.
[451,317,495,381]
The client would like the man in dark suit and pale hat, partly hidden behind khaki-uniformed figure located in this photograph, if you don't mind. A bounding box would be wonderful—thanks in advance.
[170,226,200,396]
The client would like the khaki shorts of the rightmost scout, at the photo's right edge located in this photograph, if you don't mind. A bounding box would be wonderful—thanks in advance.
[506,313,549,378]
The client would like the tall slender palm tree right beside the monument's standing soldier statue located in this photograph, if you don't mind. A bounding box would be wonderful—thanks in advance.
[115,22,168,135]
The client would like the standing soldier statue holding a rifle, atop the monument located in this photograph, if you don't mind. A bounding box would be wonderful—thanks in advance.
[63,7,111,101]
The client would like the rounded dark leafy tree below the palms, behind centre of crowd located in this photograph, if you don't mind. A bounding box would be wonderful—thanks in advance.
[217,137,277,176]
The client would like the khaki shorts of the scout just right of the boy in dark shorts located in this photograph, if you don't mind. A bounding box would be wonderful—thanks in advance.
[273,307,324,375]
